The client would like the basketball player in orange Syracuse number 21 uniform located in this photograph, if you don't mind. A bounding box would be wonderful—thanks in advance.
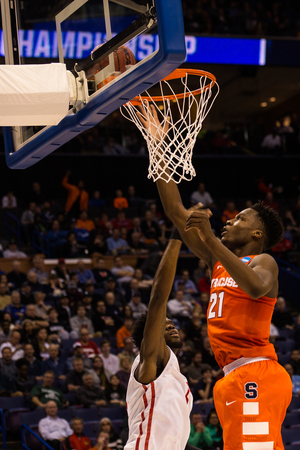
[140,106,292,450]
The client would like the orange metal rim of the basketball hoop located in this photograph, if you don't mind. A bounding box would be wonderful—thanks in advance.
[128,69,217,105]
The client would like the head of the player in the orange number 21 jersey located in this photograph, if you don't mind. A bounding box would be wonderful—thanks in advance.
[222,202,284,251]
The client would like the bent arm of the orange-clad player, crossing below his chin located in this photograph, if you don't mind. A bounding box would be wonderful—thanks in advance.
[186,212,278,299]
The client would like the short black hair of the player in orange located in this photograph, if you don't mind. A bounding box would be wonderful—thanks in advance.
[251,201,284,251]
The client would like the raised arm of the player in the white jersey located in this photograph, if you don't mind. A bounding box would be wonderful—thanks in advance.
[135,239,181,384]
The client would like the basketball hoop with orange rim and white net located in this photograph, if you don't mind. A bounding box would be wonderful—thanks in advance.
[121,69,219,183]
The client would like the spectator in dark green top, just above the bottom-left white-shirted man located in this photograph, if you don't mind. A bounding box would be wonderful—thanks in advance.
[30,370,69,408]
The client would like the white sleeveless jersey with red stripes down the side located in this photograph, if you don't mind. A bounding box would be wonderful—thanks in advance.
[124,348,193,450]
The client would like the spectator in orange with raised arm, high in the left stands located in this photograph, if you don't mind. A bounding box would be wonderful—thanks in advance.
[61,170,89,217]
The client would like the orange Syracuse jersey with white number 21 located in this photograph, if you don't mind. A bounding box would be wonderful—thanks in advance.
[207,255,277,368]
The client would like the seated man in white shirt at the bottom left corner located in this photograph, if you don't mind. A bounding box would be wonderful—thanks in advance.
[39,401,73,450]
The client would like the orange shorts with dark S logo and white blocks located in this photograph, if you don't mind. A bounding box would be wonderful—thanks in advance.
[214,360,292,450]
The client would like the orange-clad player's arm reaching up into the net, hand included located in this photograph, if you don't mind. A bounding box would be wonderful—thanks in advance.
[139,105,212,267]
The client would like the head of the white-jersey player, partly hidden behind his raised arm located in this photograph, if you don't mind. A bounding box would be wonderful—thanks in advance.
[131,313,182,350]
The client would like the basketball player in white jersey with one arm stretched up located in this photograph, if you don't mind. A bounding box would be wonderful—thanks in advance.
[124,234,195,450]
